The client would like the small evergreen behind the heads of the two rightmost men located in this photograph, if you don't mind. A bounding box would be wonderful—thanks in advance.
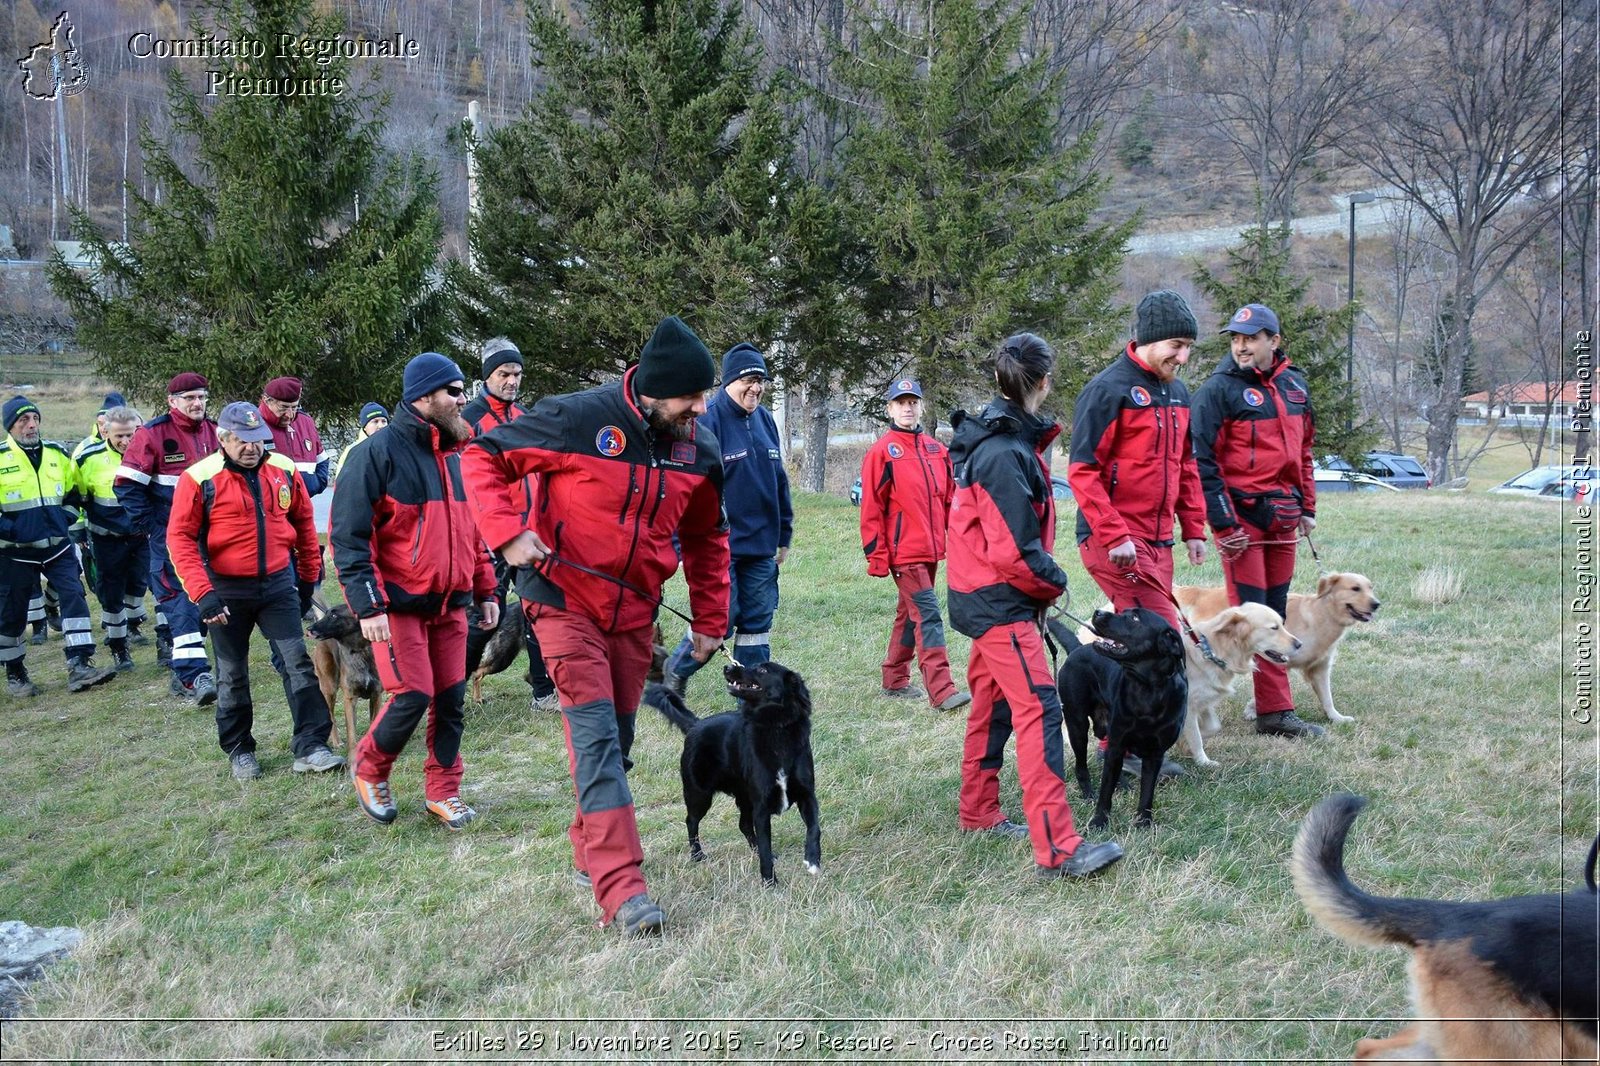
[1184,226,1376,457]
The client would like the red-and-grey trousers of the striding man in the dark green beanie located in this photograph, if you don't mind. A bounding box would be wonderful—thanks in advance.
[533,603,653,924]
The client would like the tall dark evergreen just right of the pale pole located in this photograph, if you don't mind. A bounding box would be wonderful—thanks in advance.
[450,0,792,392]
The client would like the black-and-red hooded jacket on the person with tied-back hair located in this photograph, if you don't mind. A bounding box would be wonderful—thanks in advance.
[946,399,1067,637]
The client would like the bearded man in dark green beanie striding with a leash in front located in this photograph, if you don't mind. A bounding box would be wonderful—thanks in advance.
[462,317,728,936]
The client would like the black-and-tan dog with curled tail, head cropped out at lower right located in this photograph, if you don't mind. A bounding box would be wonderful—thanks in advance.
[1291,794,1600,1063]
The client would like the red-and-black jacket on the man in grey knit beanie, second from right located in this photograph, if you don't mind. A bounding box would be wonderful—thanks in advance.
[1067,344,1205,549]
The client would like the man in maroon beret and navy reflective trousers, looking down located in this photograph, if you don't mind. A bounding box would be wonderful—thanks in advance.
[114,371,218,707]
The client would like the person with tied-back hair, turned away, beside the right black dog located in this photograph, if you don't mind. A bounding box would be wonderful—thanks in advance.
[947,333,1122,877]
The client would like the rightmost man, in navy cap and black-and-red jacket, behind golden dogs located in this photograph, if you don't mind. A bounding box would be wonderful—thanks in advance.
[1192,304,1323,736]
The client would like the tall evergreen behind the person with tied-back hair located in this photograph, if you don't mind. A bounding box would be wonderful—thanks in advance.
[838,0,1133,405]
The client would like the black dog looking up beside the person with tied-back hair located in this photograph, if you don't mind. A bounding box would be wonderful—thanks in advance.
[1051,607,1189,829]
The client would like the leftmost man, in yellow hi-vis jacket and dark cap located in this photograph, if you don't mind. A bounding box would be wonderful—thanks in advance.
[0,395,117,696]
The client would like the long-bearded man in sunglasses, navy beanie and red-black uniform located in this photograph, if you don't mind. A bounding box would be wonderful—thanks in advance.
[328,352,499,831]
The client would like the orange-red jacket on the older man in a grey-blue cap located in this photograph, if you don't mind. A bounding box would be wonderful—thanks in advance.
[166,451,322,603]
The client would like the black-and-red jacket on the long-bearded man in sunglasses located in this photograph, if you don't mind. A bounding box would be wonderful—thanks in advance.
[328,403,494,618]
